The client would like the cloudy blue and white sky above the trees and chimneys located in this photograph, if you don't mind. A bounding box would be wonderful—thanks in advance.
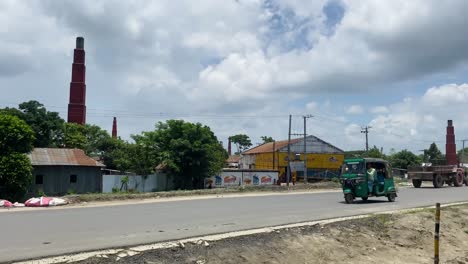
[0,0,468,153]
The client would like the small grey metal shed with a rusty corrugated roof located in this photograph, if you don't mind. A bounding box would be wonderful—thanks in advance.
[29,148,104,195]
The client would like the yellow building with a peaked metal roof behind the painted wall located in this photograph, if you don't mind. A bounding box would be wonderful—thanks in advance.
[240,135,344,179]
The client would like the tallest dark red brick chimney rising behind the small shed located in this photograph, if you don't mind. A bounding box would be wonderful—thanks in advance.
[68,37,86,125]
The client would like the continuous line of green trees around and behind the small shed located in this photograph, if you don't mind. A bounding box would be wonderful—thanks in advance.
[0,101,227,200]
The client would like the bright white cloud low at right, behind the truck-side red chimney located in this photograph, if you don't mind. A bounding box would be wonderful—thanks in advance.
[369,84,468,152]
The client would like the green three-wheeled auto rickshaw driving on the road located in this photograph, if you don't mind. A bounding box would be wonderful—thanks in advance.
[340,158,397,204]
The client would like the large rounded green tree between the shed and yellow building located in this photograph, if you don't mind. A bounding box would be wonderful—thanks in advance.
[139,120,227,189]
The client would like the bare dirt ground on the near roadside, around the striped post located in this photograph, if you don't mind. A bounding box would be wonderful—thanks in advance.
[65,205,468,264]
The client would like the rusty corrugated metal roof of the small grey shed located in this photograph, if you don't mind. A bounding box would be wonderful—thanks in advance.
[28,148,105,167]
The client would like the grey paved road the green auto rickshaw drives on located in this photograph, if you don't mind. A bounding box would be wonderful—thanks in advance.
[0,187,468,262]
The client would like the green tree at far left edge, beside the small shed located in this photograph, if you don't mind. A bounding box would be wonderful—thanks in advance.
[0,113,34,200]
